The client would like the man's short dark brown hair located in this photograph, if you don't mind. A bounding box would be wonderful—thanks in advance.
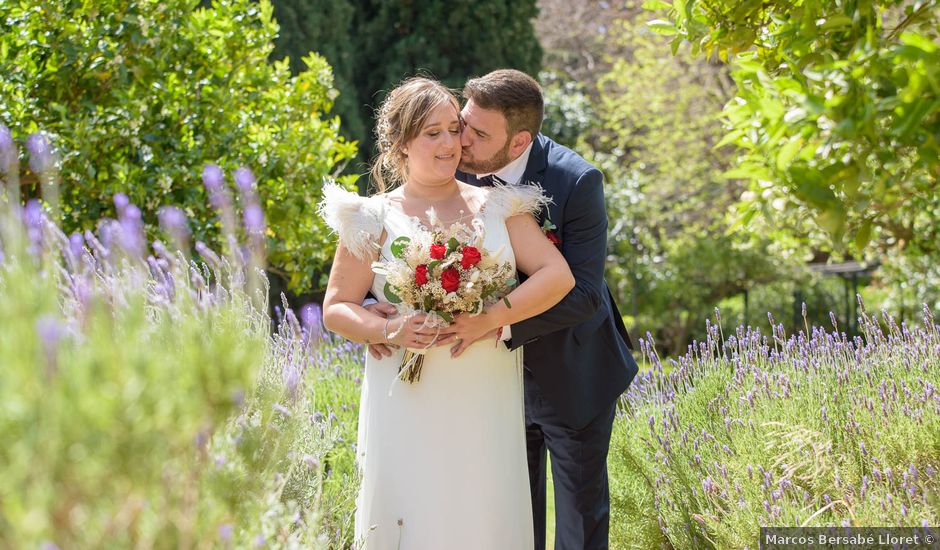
[463,69,545,139]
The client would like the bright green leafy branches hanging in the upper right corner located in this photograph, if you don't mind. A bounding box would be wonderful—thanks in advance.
[647,0,940,258]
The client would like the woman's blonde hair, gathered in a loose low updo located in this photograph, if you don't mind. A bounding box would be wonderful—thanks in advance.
[372,76,460,193]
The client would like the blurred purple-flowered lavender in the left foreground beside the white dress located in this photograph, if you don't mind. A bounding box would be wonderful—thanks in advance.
[0,127,362,548]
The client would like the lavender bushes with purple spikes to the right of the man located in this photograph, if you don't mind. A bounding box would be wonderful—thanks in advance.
[610,307,940,548]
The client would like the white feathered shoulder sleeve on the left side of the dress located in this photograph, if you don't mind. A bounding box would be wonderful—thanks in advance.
[318,181,383,260]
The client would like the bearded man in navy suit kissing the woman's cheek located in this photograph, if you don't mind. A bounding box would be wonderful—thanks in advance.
[458,69,637,550]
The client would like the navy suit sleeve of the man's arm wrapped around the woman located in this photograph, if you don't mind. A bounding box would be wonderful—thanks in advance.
[510,168,607,349]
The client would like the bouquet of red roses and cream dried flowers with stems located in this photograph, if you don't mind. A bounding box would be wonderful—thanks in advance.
[372,220,516,383]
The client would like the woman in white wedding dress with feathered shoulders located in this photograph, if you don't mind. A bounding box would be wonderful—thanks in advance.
[320,78,574,550]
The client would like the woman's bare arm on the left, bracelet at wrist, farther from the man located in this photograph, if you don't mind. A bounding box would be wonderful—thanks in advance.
[323,243,436,348]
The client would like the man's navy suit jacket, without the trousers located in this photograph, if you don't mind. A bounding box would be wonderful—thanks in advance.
[458,134,637,429]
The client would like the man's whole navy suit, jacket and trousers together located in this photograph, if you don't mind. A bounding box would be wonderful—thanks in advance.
[459,134,637,550]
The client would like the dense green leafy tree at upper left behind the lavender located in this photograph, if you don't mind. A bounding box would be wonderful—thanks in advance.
[0,0,355,290]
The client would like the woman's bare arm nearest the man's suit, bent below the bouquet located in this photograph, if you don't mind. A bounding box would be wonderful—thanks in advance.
[448,214,575,357]
